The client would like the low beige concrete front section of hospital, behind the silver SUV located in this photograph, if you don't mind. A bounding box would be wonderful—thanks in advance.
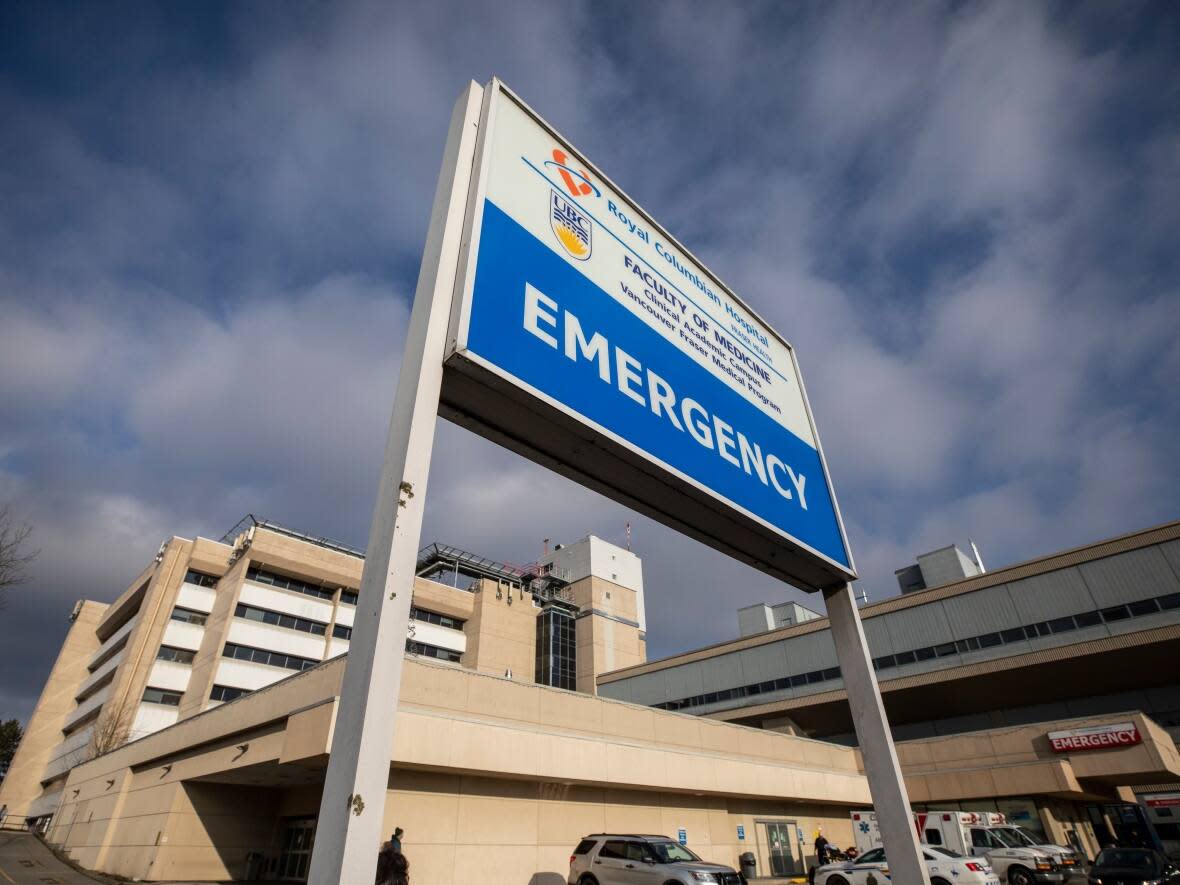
[43,660,868,885]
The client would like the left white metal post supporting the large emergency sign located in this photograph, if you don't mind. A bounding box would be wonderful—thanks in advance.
[308,83,483,885]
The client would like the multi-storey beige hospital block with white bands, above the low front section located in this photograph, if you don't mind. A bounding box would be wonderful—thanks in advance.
[0,522,644,835]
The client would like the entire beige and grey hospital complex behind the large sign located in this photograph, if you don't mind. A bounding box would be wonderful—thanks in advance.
[0,518,1180,885]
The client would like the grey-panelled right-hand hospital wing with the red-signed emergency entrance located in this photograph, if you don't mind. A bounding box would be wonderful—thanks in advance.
[598,523,1180,854]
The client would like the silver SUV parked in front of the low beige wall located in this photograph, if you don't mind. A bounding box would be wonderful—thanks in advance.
[566,833,746,885]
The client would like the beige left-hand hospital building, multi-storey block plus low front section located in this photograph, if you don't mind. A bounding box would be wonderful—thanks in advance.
[0,524,868,885]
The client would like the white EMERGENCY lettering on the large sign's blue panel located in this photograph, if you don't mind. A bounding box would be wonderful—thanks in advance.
[523,283,807,510]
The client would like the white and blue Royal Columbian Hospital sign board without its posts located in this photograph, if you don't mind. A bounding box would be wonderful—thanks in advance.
[444,81,854,589]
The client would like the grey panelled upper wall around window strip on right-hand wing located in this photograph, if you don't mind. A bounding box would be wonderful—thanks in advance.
[598,523,1180,715]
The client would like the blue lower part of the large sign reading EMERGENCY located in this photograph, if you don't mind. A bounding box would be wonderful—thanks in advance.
[467,201,848,565]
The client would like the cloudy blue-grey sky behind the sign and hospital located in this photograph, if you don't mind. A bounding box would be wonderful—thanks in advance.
[0,0,1180,717]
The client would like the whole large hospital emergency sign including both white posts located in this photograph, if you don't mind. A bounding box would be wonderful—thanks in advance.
[310,80,927,885]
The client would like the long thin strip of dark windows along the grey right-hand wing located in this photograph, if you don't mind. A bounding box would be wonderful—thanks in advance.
[654,594,1180,710]
